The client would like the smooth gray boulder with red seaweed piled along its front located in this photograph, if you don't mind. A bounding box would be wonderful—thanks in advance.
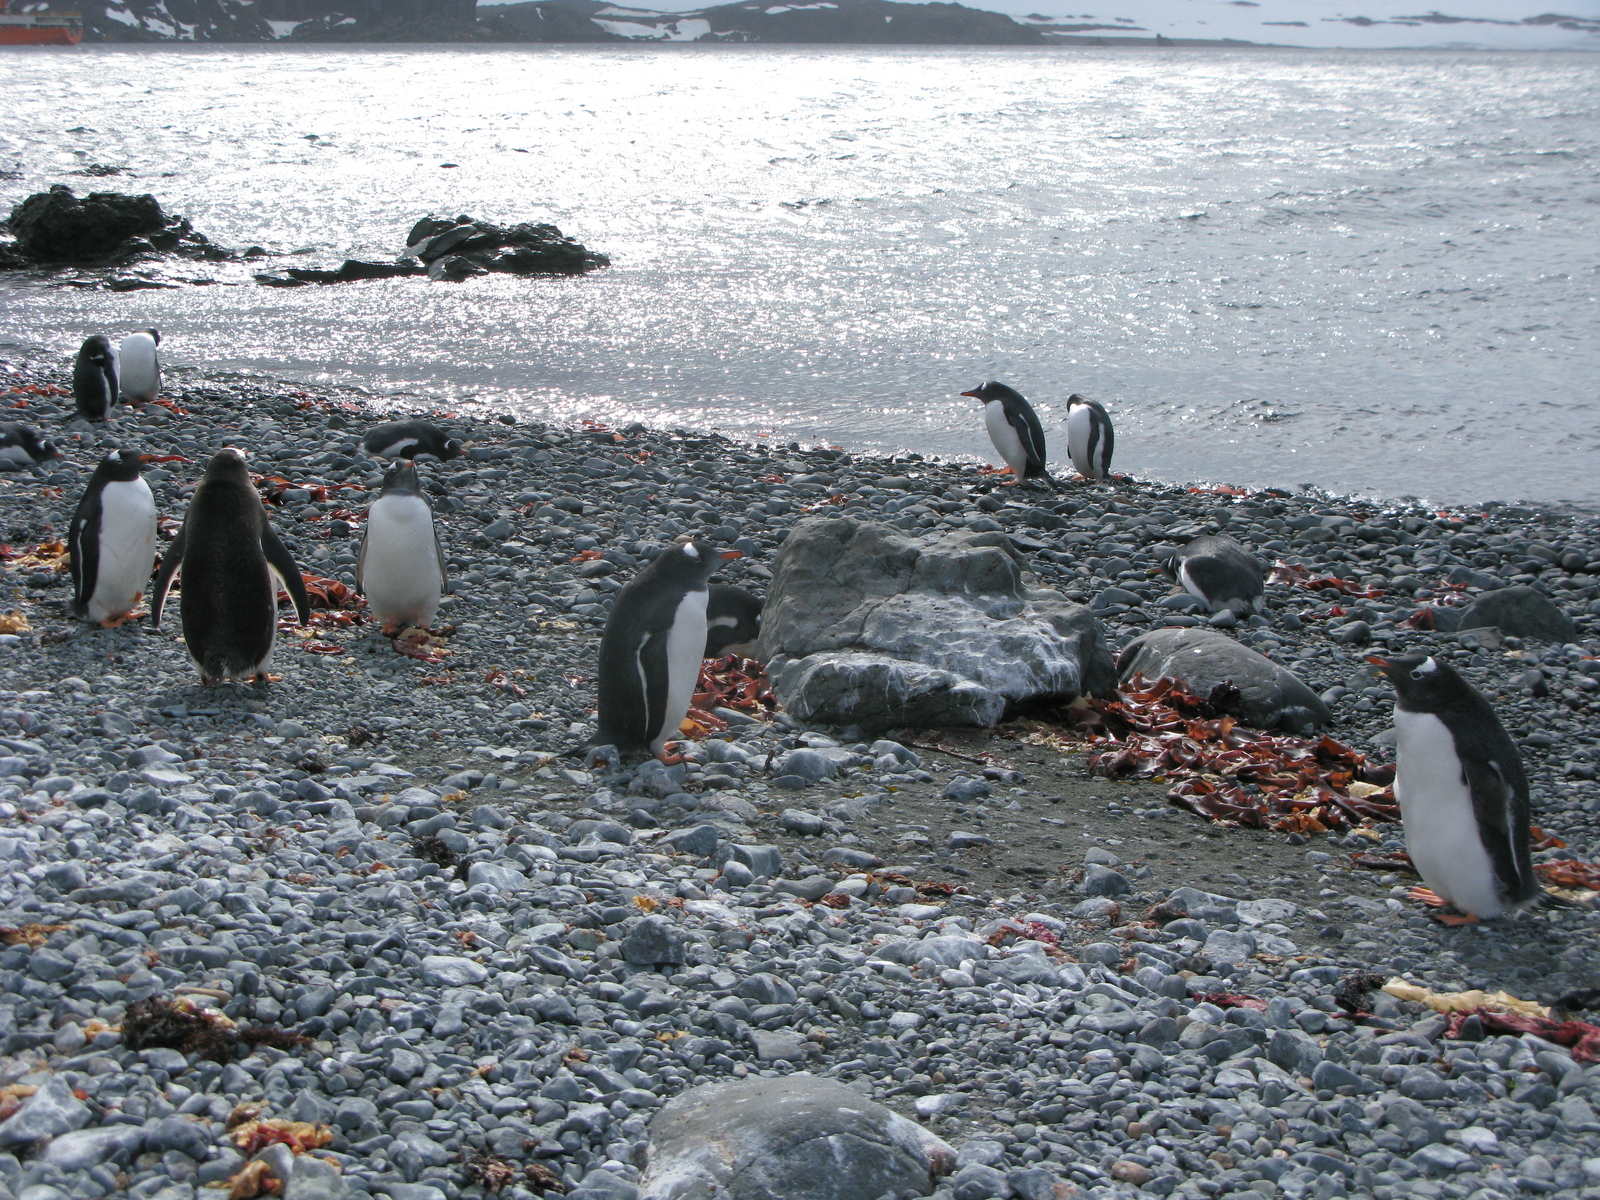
[1117,629,1333,733]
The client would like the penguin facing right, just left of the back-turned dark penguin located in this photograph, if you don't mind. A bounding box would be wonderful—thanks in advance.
[67,450,155,629]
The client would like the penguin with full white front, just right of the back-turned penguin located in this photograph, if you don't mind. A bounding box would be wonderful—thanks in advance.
[355,461,450,634]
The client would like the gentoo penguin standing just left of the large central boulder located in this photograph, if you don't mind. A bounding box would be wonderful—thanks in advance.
[590,542,739,757]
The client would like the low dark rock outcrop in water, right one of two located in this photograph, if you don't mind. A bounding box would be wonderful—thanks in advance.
[256,216,611,288]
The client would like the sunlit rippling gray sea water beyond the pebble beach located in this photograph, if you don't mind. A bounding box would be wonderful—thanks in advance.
[0,46,1600,507]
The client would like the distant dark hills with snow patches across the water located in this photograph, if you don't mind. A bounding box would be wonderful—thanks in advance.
[68,0,1600,50]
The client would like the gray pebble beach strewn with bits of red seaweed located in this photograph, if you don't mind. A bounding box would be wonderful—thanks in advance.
[0,360,1600,1200]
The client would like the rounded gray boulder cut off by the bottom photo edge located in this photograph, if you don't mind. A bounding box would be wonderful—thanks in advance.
[638,1074,955,1200]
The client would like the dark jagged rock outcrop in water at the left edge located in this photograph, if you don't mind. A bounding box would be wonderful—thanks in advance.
[0,184,234,269]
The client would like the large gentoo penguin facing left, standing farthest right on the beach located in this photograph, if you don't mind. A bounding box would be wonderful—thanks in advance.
[1366,654,1541,925]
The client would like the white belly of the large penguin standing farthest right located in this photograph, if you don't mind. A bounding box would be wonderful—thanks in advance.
[1395,709,1506,917]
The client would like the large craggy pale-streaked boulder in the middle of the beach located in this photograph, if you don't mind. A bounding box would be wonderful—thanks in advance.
[760,517,1115,730]
